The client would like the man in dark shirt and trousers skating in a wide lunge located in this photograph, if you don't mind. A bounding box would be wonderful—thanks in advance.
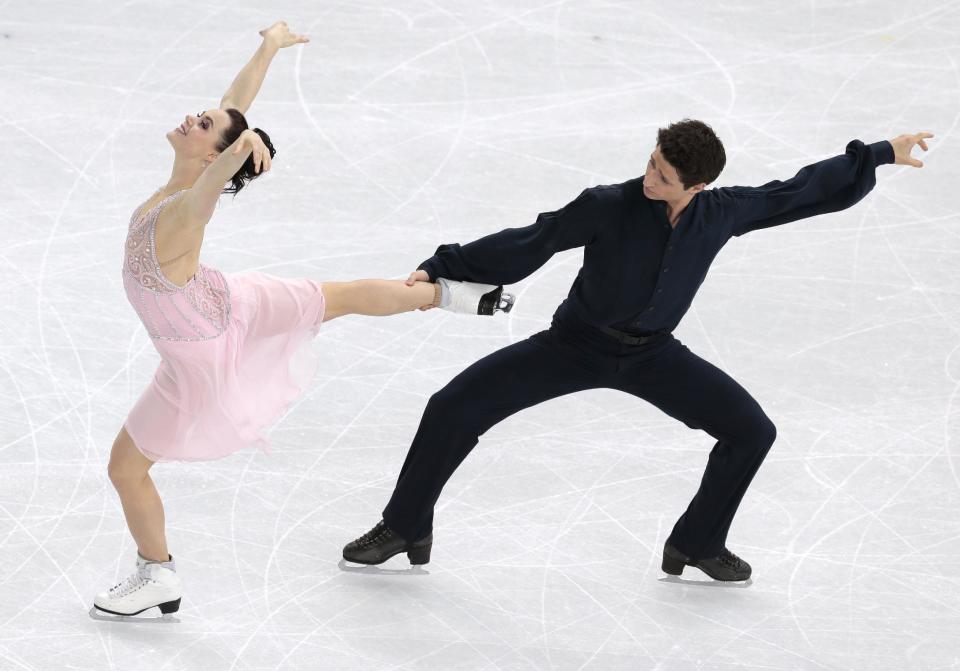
[343,119,933,580]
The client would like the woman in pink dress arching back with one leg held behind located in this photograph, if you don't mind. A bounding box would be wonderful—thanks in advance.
[91,21,512,616]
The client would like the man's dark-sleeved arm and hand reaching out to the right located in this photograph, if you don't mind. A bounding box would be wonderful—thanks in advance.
[715,133,933,236]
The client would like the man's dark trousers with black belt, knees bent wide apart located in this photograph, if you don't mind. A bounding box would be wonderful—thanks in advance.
[383,315,776,559]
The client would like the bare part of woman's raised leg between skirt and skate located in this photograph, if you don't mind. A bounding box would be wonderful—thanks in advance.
[323,280,438,322]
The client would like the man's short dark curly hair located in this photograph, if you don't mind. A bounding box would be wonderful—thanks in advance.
[657,119,727,189]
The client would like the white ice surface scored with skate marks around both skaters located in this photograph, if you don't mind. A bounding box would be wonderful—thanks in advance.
[0,0,960,671]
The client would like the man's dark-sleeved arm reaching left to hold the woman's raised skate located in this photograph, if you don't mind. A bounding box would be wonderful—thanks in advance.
[407,188,603,285]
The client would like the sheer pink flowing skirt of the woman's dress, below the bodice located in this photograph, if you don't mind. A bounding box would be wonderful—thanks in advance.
[124,272,325,461]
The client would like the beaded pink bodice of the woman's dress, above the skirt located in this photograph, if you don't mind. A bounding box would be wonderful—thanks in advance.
[123,191,230,340]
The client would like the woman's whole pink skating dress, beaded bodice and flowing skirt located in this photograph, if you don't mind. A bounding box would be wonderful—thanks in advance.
[123,191,325,461]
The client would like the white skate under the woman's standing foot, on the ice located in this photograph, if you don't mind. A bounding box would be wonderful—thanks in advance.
[90,553,182,622]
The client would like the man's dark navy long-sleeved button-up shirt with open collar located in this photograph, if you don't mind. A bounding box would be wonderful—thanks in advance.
[418,140,894,333]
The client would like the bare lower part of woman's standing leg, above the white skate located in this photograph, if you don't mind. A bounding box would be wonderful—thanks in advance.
[107,428,169,562]
